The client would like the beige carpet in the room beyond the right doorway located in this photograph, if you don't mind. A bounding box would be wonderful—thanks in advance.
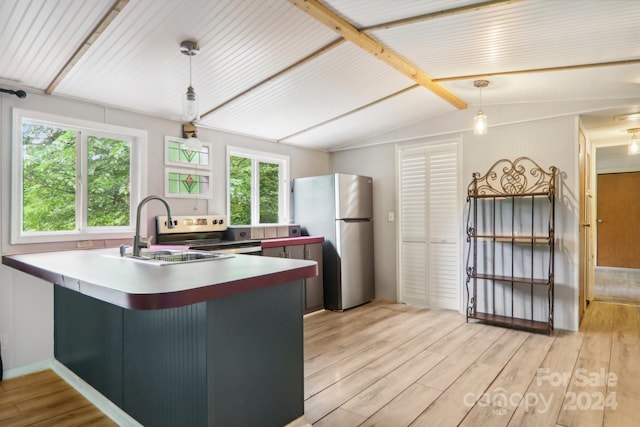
[595,267,640,304]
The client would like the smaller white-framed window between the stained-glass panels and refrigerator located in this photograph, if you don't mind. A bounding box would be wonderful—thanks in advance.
[227,147,289,225]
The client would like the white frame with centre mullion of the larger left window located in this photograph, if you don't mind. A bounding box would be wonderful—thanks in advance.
[10,108,148,244]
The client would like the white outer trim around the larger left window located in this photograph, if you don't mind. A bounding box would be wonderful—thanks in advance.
[11,108,148,244]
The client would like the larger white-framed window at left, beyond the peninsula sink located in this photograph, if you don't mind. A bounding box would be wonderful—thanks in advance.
[11,109,146,243]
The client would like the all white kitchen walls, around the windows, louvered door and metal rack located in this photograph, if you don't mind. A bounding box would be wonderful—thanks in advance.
[0,93,592,369]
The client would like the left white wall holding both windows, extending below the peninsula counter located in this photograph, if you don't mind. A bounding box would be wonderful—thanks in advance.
[0,93,330,372]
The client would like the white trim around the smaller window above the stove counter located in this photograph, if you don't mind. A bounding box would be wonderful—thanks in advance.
[226,145,291,225]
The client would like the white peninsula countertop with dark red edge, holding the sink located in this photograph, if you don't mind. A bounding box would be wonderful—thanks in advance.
[2,248,318,310]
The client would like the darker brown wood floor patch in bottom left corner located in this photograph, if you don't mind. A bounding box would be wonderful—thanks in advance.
[0,370,116,427]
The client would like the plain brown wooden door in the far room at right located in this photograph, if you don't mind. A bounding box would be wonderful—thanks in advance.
[597,172,640,268]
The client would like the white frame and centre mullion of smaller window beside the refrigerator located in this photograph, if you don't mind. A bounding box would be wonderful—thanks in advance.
[226,146,291,226]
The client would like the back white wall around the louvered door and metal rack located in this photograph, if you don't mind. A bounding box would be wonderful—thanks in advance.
[331,116,578,330]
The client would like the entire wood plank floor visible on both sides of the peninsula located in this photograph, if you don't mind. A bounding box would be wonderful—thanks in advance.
[0,302,640,427]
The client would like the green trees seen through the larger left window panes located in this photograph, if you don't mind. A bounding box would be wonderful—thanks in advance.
[22,123,131,232]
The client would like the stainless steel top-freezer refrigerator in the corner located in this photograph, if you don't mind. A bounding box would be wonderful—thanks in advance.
[293,173,375,311]
